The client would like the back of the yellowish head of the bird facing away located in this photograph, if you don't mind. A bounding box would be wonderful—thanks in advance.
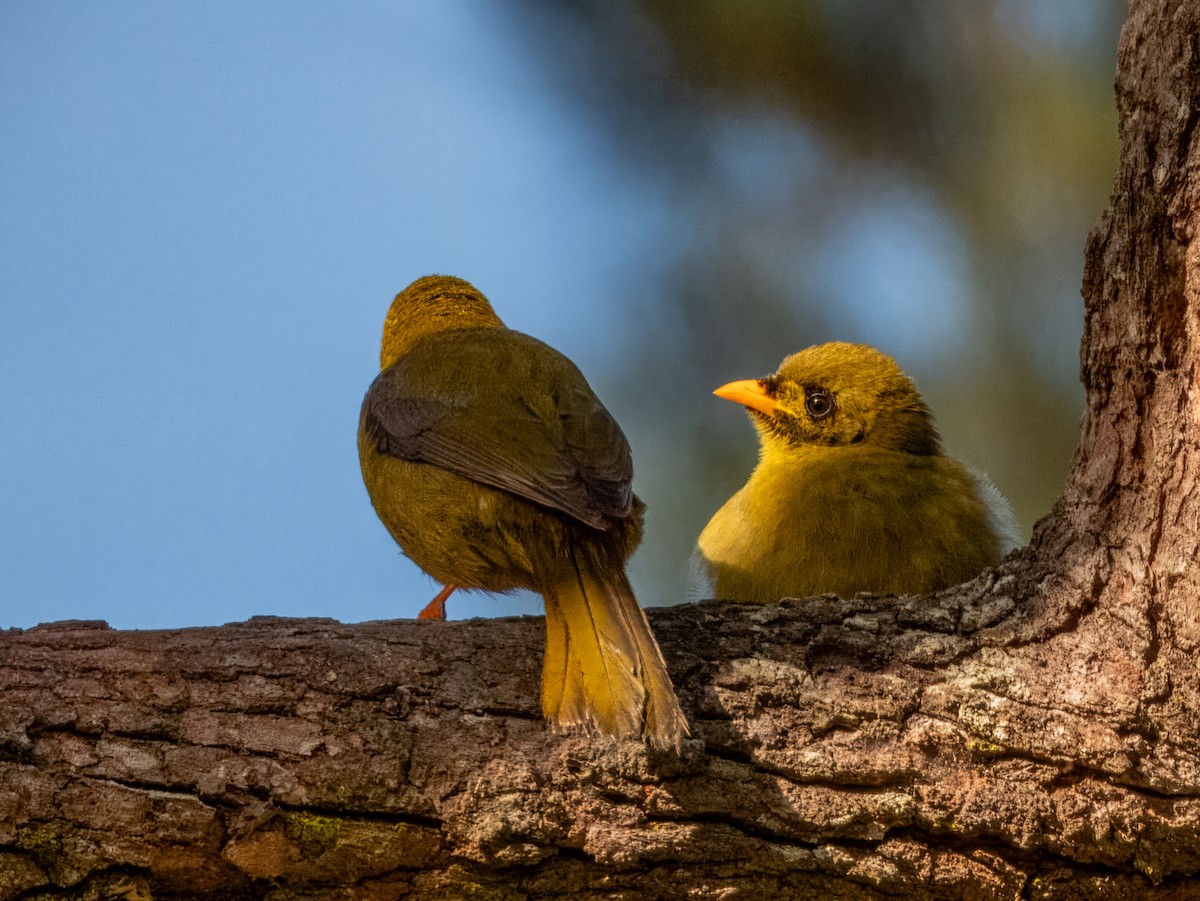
[379,275,504,370]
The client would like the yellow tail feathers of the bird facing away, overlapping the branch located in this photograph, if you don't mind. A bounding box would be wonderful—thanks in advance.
[541,548,688,750]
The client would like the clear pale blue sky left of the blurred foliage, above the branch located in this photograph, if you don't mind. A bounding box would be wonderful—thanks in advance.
[0,0,662,627]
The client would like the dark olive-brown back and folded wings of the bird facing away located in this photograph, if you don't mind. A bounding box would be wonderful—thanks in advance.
[362,329,634,529]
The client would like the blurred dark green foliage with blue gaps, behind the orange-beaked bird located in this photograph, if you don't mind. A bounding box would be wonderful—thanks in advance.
[506,0,1124,603]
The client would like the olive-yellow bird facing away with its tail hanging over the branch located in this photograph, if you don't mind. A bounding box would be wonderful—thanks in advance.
[358,275,689,751]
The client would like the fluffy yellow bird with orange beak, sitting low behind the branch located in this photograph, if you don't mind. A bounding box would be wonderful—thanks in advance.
[692,342,1022,603]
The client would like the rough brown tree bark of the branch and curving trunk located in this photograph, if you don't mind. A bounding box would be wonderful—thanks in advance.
[0,0,1200,901]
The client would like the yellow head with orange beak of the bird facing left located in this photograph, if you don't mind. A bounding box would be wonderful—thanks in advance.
[714,342,941,455]
